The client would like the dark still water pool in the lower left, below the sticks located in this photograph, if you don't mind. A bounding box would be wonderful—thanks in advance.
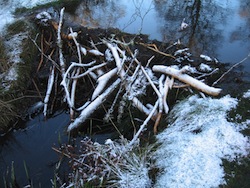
[0,112,69,187]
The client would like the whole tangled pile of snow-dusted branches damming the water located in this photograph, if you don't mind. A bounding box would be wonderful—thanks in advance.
[34,8,221,142]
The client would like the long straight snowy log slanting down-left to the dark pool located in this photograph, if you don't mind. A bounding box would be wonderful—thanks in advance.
[67,79,121,132]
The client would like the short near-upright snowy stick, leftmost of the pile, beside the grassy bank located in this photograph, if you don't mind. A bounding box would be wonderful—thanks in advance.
[43,66,55,117]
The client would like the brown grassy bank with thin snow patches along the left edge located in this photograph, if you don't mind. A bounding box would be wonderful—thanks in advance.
[0,20,37,132]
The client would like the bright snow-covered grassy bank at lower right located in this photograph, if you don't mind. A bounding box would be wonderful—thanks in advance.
[155,96,250,188]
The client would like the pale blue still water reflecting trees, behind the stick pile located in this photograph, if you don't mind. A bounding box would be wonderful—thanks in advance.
[66,0,250,71]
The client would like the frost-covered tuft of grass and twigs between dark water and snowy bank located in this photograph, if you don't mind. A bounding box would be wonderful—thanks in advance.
[61,138,151,188]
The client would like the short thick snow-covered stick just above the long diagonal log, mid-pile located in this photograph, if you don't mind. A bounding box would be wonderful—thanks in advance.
[91,68,118,100]
